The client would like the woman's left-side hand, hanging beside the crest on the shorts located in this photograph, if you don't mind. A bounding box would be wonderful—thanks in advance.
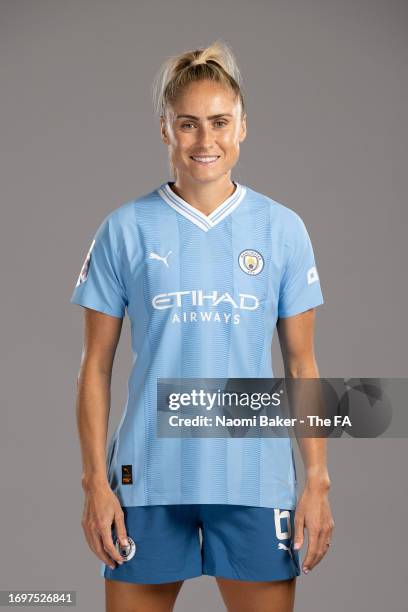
[81,484,128,569]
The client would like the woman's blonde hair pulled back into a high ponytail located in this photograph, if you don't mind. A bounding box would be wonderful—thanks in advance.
[153,40,245,117]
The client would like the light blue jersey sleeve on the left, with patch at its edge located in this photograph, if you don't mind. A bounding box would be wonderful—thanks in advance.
[70,214,127,318]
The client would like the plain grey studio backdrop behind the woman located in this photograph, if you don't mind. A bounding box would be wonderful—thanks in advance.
[0,0,408,612]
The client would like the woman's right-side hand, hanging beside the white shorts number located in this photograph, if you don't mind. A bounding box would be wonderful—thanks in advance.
[294,485,334,574]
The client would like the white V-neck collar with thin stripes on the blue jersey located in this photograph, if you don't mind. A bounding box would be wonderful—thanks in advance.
[157,181,246,232]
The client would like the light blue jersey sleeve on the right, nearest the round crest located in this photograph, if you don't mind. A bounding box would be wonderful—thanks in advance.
[278,211,324,318]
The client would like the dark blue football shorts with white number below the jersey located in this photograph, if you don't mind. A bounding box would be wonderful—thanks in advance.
[100,504,301,584]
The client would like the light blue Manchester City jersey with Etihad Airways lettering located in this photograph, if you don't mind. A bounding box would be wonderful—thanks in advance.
[71,181,323,509]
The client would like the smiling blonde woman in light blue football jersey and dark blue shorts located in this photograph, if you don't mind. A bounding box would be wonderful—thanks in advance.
[71,42,333,612]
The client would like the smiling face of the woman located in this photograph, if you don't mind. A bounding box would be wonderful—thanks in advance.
[160,80,246,183]
